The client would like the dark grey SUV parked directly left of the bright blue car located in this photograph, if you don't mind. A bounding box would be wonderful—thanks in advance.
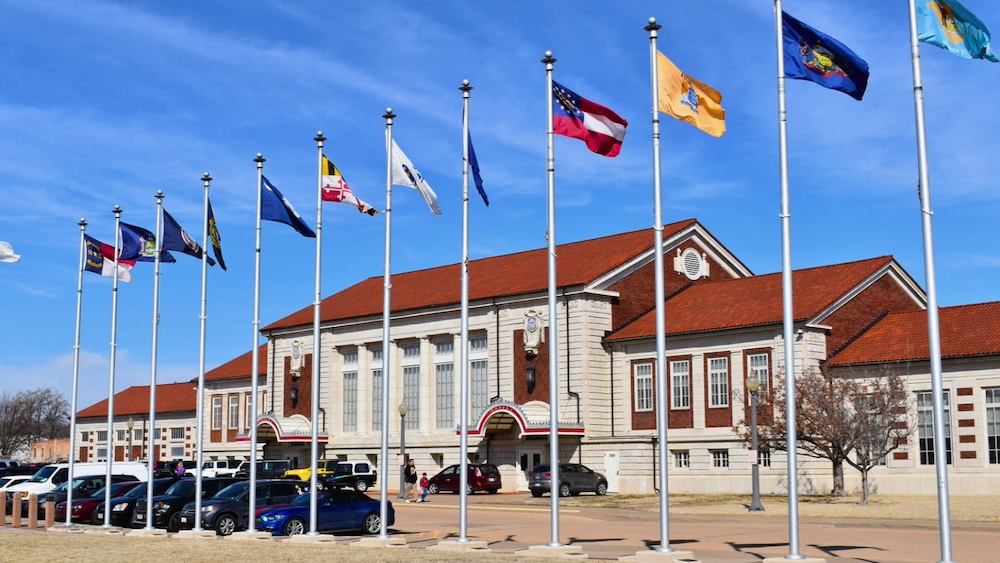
[180,479,306,536]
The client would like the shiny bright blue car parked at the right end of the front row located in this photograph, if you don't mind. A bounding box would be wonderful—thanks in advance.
[257,490,396,536]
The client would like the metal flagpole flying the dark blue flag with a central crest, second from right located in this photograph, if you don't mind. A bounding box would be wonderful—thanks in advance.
[774,0,802,559]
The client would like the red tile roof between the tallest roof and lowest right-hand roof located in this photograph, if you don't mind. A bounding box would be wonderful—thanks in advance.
[606,256,893,341]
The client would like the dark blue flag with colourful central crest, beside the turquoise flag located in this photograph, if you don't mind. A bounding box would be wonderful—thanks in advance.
[781,12,868,100]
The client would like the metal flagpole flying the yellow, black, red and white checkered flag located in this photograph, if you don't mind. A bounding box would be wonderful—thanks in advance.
[307,131,328,536]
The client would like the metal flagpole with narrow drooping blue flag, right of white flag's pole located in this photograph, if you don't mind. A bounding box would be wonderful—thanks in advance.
[458,80,472,542]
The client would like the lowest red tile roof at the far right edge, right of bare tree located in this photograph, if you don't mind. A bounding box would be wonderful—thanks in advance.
[827,301,1000,366]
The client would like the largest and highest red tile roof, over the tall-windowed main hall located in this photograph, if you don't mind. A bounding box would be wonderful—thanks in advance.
[262,219,697,331]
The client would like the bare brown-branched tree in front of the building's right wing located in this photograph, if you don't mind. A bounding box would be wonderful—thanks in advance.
[734,370,909,504]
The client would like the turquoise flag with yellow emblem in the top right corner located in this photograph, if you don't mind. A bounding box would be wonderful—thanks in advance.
[917,0,1000,62]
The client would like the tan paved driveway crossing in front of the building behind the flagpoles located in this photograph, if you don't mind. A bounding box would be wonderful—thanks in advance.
[393,494,1000,563]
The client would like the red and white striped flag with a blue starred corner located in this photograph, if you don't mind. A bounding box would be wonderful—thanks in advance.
[552,80,628,157]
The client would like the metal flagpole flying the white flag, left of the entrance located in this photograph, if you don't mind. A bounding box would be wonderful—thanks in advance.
[378,108,396,539]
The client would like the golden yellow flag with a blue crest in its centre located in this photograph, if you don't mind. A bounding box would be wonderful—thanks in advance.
[656,51,726,137]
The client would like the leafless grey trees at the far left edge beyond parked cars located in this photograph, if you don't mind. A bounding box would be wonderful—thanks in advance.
[0,387,69,457]
